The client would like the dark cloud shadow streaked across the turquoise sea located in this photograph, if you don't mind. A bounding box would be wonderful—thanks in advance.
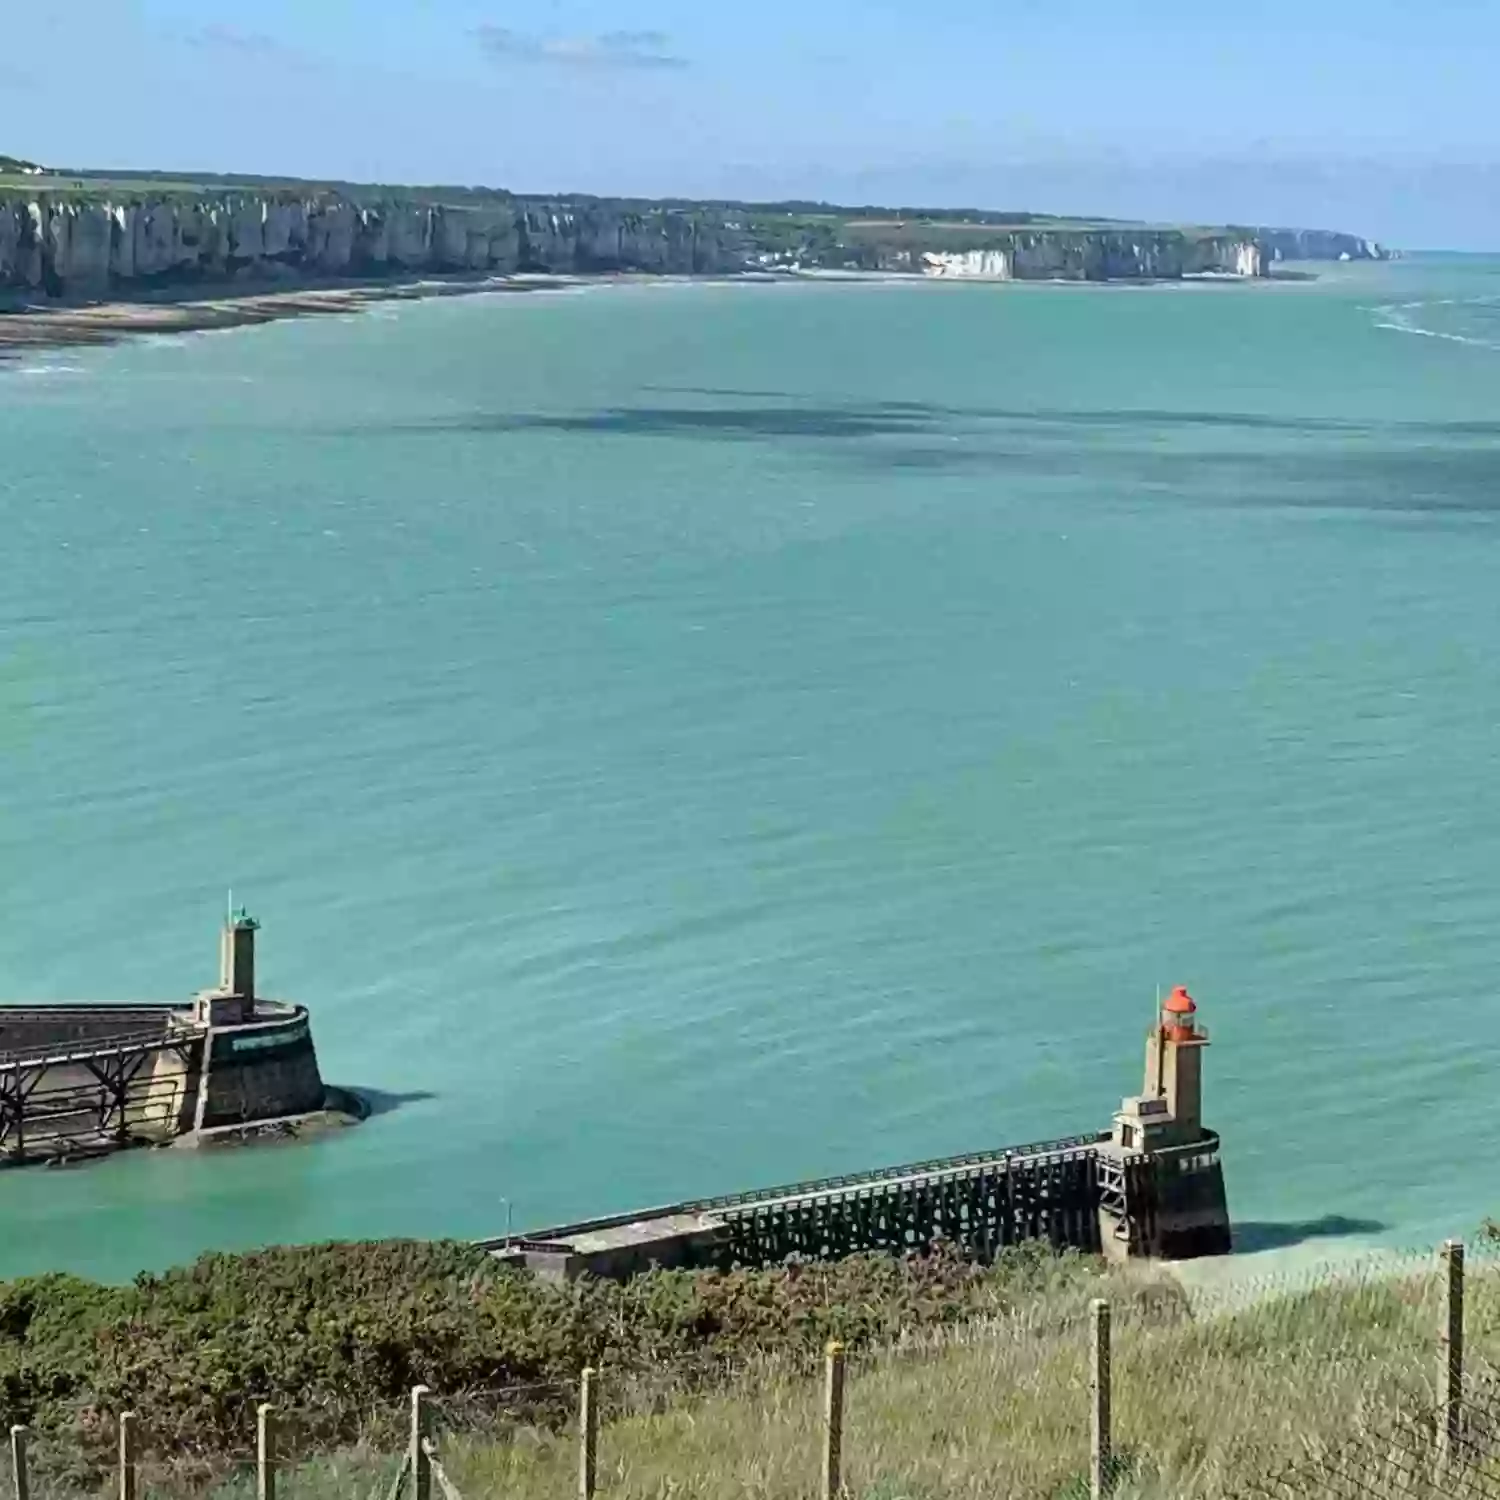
[348,387,1500,516]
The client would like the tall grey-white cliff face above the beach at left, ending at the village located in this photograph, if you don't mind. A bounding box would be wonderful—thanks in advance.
[0,195,749,296]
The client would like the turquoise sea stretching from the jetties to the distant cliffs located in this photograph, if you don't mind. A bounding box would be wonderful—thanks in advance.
[0,260,1500,1277]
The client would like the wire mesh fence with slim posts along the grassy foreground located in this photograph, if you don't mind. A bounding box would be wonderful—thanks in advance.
[11,1248,1500,1500]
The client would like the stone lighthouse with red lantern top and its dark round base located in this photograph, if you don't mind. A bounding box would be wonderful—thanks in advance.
[1097,984,1232,1260]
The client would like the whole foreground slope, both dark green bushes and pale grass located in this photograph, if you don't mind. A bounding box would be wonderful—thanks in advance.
[0,1244,1500,1500]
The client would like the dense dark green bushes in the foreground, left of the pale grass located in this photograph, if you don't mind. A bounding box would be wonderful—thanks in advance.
[0,1241,1094,1466]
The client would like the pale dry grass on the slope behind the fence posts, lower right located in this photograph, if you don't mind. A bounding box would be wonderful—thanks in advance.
[387,1271,1500,1500]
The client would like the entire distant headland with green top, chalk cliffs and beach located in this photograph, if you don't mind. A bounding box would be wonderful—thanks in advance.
[0,156,1389,350]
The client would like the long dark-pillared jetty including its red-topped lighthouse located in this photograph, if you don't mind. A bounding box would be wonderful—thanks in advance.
[480,987,1232,1278]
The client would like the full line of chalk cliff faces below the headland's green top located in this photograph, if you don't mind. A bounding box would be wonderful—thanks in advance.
[0,191,1385,297]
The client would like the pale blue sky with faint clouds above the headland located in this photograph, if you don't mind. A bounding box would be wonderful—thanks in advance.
[0,0,1500,249]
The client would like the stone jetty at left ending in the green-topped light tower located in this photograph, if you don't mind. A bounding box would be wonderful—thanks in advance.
[0,911,345,1166]
